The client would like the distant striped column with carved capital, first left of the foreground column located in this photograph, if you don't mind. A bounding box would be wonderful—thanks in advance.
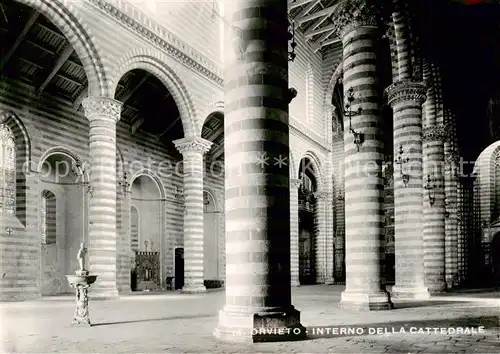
[174,138,212,293]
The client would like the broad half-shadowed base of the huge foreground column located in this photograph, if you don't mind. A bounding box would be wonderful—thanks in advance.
[214,306,307,343]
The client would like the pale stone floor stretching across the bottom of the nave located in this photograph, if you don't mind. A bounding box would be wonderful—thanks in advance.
[0,285,500,353]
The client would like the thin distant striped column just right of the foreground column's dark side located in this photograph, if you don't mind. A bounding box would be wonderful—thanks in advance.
[290,178,301,286]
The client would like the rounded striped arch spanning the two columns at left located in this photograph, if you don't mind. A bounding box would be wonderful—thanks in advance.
[110,49,198,137]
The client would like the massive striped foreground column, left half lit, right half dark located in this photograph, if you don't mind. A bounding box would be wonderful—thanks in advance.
[214,0,305,342]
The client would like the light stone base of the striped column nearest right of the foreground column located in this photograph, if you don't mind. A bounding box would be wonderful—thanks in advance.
[339,290,394,311]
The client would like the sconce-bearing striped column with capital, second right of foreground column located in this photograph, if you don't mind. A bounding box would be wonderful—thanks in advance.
[386,80,429,299]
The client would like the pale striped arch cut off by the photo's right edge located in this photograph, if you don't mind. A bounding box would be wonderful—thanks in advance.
[474,141,500,224]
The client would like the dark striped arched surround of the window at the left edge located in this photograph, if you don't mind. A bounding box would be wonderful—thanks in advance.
[0,109,31,225]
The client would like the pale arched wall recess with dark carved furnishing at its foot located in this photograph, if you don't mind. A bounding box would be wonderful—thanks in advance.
[128,169,167,291]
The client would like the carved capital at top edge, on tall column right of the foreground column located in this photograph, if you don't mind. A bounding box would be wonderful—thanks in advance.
[332,0,381,38]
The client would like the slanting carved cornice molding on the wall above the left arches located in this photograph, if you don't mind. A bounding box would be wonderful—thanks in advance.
[86,0,223,86]
